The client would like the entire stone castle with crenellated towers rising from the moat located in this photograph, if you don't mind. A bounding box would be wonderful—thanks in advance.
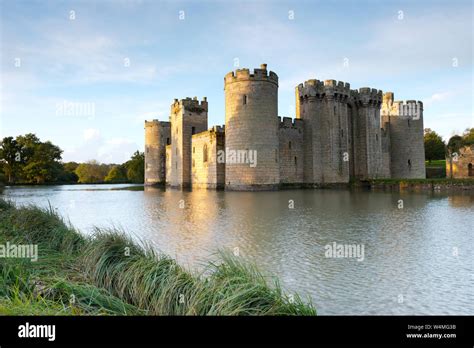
[145,64,425,190]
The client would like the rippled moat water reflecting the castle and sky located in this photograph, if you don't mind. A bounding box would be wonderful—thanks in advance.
[4,185,474,315]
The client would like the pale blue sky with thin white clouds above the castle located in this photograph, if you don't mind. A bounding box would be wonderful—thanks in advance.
[0,0,474,163]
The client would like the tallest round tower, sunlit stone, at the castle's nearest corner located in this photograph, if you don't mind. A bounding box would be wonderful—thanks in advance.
[224,64,280,190]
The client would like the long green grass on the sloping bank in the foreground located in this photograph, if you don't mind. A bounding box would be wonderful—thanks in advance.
[0,200,316,315]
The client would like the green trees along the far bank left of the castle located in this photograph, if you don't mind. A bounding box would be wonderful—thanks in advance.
[0,133,145,184]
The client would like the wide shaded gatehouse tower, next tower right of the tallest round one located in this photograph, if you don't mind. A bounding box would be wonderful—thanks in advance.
[296,80,350,184]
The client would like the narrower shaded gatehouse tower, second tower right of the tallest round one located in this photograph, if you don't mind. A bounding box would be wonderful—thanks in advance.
[350,87,385,180]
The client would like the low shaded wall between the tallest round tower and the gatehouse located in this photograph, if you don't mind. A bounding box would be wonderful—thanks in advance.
[279,117,304,184]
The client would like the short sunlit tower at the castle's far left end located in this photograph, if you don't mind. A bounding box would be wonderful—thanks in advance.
[145,120,171,185]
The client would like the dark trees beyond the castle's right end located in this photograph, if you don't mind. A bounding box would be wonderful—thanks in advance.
[424,128,474,162]
